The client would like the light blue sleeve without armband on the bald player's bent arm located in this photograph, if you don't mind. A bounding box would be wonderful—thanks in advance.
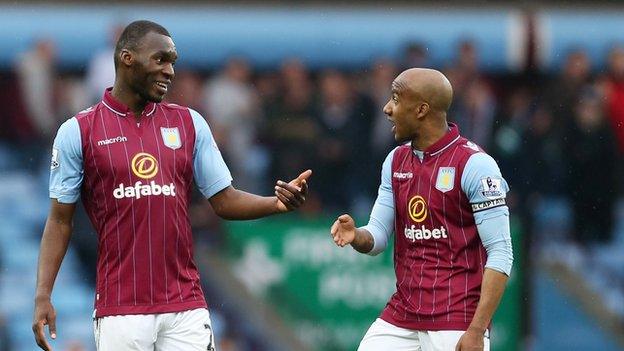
[362,148,396,256]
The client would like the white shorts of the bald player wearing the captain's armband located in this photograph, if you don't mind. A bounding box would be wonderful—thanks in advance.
[358,318,490,351]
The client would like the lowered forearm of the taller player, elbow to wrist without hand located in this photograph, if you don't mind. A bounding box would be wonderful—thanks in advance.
[35,218,72,298]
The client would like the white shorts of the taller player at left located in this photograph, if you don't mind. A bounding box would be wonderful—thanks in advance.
[93,308,215,351]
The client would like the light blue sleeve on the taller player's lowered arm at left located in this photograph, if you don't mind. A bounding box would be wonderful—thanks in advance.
[49,117,84,204]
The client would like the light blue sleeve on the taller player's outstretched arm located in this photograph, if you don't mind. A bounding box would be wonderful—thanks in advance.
[190,110,232,198]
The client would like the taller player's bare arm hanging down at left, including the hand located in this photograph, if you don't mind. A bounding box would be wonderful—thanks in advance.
[32,199,76,350]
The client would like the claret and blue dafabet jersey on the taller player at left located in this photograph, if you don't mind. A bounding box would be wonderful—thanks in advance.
[50,90,232,317]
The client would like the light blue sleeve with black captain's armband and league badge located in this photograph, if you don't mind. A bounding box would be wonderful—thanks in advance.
[461,152,513,275]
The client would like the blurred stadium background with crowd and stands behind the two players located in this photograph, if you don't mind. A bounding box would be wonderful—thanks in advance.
[0,2,624,351]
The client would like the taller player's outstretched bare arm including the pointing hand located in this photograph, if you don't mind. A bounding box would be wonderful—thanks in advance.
[209,170,312,219]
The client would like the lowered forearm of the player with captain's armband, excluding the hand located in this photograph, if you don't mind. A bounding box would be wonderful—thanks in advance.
[468,268,508,333]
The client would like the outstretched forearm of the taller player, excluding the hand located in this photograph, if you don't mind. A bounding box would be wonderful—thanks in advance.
[210,188,279,220]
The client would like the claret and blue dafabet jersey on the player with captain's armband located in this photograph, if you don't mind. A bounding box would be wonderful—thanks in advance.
[364,124,513,330]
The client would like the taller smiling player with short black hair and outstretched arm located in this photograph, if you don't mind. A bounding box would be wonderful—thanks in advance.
[33,21,311,351]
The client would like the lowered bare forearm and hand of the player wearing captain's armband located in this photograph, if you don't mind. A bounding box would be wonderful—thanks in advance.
[456,268,508,351]
